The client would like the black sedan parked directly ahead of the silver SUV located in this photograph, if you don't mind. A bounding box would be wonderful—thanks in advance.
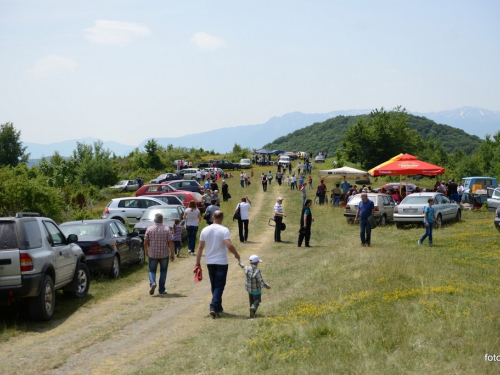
[59,219,145,279]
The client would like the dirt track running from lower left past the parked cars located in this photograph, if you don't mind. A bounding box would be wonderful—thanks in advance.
[0,191,272,375]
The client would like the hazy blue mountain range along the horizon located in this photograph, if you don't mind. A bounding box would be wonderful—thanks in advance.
[23,107,500,159]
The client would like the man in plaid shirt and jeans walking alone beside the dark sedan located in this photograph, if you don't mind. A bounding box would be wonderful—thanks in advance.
[144,213,175,295]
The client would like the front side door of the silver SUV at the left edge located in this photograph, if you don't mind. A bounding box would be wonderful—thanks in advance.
[43,220,76,288]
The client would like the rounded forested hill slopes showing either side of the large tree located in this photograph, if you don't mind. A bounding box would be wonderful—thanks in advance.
[264,115,482,154]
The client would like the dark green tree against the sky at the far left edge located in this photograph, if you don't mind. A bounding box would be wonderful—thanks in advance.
[0,122,30,167]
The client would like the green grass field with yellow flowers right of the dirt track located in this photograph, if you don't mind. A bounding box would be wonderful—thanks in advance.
[0,163,500,374]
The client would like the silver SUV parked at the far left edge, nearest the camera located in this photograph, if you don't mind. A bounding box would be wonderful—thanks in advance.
[0,212,90,320]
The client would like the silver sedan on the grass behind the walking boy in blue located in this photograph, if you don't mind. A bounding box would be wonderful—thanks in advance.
[394,192,462,228]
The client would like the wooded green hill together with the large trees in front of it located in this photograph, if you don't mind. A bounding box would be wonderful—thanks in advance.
[264,107,500,179]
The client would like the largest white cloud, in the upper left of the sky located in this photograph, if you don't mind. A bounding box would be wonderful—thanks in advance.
[85,20,151,45]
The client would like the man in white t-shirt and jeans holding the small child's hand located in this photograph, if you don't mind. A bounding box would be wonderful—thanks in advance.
[196,211,240,319]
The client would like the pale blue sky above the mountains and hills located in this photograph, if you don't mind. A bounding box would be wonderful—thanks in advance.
[0,0,500,145]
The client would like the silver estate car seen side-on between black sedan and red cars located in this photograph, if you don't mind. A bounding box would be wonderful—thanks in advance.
[101,197,166,225]
